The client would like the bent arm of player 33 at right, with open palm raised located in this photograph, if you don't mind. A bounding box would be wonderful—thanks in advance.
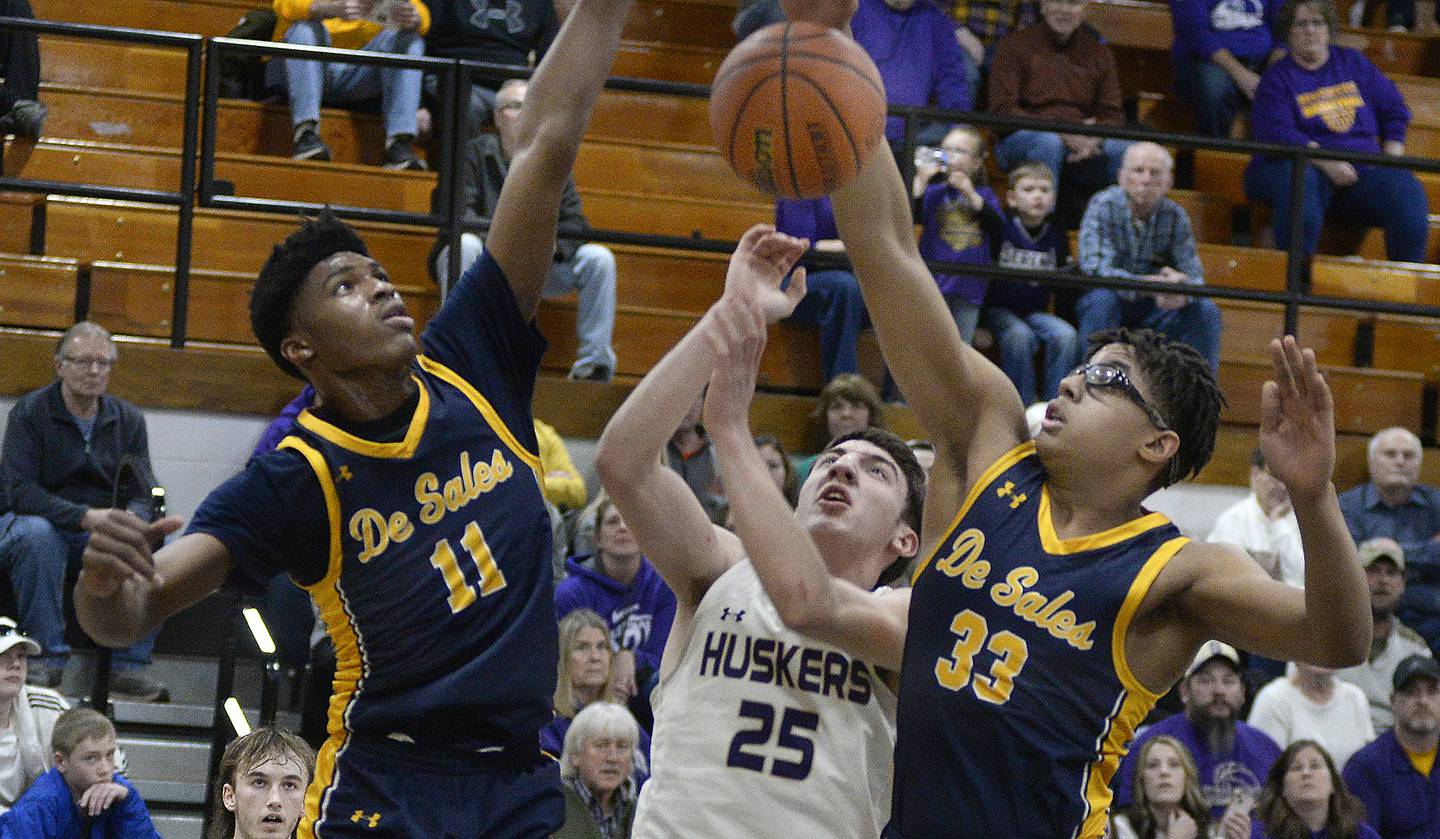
[1182,337,1372,668]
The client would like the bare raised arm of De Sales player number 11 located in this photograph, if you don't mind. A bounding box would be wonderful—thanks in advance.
[485,0,631,318]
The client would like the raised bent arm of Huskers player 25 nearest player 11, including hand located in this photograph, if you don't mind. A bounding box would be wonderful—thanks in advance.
[595,225,805,612]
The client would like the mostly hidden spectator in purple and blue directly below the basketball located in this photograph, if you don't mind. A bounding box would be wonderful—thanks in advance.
[775,199,870,391]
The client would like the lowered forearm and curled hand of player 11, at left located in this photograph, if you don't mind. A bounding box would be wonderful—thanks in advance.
[75,509,232,648]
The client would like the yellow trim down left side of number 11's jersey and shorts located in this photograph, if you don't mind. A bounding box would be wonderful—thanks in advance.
[276,432,366,839]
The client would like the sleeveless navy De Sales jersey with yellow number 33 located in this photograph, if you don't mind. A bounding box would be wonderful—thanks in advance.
[890,442,1188,839]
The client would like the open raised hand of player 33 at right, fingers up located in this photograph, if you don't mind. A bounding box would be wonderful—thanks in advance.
[1260,335,1335,498]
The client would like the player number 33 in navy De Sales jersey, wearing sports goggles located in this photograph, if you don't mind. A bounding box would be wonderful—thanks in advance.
[786,0,1369,839]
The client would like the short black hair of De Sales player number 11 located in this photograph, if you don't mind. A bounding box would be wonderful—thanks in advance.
[251,207,370,378]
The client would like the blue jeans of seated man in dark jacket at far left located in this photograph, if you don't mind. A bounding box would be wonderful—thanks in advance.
[0,512,160,669]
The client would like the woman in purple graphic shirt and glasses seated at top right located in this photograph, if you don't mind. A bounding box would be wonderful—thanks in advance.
[1246,0,1428,262]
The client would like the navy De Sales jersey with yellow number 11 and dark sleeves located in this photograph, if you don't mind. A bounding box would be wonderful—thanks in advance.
[200,253,557,759]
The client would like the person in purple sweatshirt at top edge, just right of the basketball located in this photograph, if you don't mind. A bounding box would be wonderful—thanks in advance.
[850,0,975,150]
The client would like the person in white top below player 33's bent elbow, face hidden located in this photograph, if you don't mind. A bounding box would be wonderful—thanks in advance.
[1250,662,1375,764]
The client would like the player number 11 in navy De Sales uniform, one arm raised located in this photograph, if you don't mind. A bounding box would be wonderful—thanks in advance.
[64,0,629,839]
